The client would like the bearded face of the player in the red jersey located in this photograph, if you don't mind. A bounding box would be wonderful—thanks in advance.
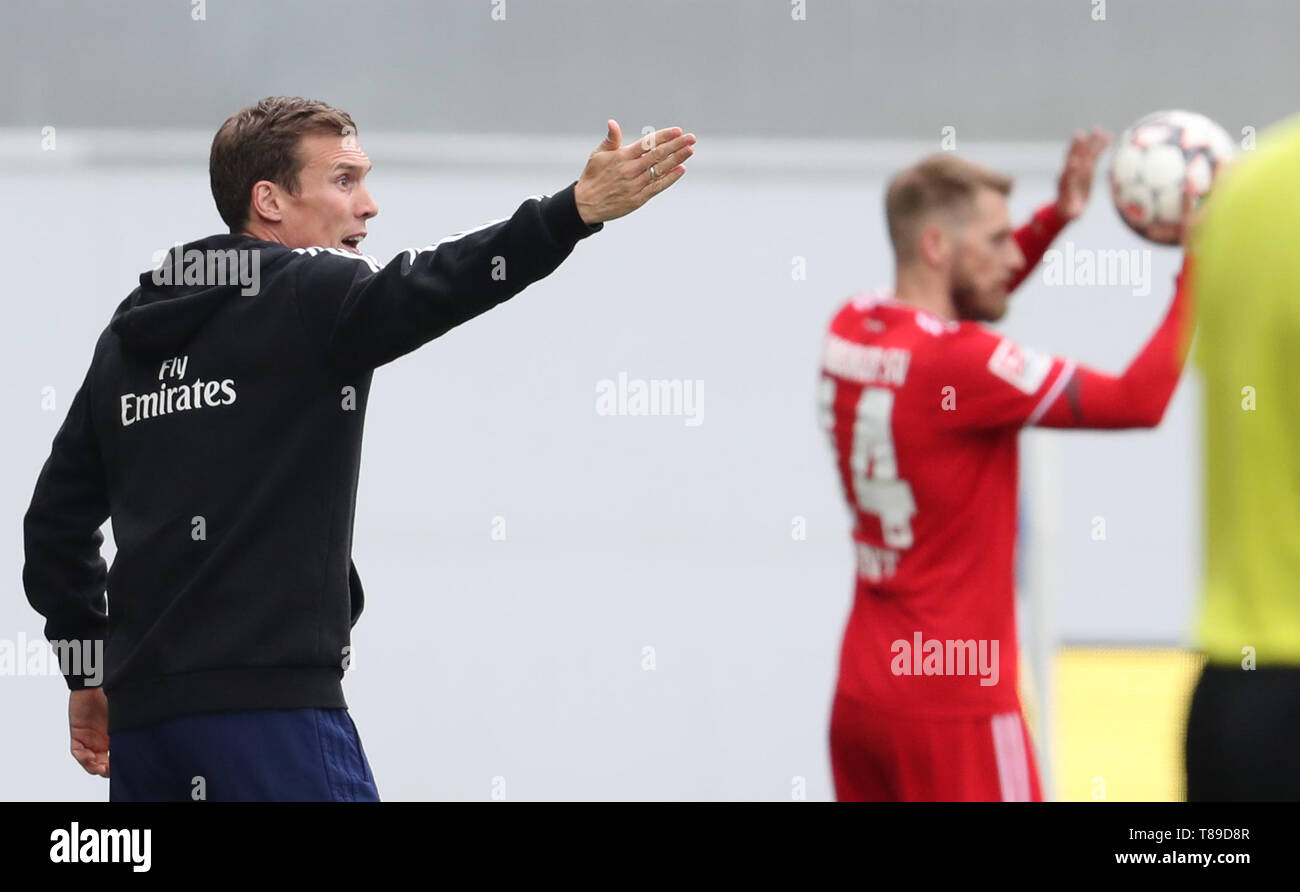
[952,189,1024,322]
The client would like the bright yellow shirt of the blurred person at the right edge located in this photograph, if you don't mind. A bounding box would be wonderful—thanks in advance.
[1192,116,1300,666]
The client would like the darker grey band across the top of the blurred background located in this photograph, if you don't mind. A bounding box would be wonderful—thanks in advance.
[0,0,1300,139]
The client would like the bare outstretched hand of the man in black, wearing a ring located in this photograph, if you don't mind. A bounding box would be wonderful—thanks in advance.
[573,120,696,225]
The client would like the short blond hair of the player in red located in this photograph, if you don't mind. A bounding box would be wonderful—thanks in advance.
[885,152,1011,264]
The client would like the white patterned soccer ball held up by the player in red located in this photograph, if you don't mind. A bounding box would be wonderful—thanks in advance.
[1110,112,1236,244]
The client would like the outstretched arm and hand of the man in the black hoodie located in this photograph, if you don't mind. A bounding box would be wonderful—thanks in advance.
[296,120,696,371]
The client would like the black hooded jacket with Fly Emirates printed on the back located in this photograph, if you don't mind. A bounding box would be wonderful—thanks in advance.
[22,185,602,732]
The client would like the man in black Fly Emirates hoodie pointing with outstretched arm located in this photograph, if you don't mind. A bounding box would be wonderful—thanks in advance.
[23,96,694,801]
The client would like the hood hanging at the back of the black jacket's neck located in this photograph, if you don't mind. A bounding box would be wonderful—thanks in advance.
[109,234,289,359]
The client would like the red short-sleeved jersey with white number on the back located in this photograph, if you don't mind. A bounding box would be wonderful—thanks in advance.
[820,295,1073,714]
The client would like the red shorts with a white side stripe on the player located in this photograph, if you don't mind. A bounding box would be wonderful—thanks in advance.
[831,694,1043,802]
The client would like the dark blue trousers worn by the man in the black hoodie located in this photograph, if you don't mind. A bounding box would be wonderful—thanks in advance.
[108,709,380,802]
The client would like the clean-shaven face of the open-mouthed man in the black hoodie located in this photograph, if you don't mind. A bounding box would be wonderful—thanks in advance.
[253,134,380,254]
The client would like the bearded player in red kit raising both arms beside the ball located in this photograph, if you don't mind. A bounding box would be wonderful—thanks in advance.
[820,130,1193,801]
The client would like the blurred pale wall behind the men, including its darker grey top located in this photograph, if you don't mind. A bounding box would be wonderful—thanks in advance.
[0,0,1279,800]
